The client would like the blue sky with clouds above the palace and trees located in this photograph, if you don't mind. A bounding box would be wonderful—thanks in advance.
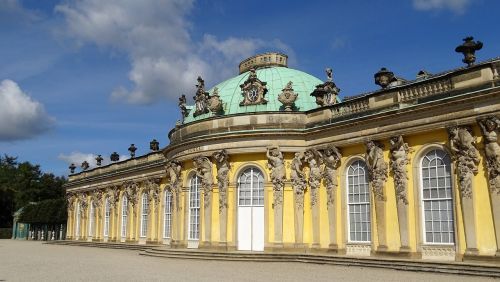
[0,0,500,175]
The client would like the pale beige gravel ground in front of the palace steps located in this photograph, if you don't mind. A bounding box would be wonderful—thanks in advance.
[0,240,493,282]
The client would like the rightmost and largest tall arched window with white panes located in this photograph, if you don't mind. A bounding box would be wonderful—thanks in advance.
[421,150,455,244]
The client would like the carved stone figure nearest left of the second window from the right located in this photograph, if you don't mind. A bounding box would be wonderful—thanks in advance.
[323,145,342,204]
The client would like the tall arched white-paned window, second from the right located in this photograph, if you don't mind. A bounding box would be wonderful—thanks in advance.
[347,160,371,242]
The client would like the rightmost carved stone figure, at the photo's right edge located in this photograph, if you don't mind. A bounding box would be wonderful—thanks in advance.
[478,117,500,193]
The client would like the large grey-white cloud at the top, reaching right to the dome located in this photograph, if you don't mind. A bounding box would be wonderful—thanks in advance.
[56,0,289,104]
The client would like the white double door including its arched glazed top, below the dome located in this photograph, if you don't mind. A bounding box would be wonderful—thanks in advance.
[238,168,264,251]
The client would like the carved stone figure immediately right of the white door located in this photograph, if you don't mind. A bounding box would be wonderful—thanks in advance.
[266,146,285,206]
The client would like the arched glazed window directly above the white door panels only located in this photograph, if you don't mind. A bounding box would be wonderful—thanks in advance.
[238,167,264,206]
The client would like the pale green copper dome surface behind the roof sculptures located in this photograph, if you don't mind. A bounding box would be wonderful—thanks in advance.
[184,66,323,123]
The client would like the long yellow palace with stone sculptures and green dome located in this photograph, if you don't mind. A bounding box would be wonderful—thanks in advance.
[66,39,500,260]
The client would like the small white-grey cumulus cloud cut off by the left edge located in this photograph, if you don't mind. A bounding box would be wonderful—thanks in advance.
[0,79,54,141]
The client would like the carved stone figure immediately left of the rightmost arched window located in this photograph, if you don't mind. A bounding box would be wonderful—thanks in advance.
[389,135,410,205]
